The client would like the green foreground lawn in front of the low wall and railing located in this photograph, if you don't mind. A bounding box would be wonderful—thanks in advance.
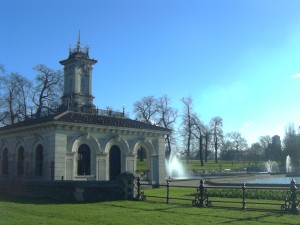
[0,188,300,225]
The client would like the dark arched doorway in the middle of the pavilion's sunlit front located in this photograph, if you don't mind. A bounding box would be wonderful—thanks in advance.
[109,145,121,180]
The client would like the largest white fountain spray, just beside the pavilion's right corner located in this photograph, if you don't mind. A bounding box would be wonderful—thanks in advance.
[166,154,186,178]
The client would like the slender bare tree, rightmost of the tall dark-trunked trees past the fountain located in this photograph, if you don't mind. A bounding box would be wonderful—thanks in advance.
[210,116,223,163]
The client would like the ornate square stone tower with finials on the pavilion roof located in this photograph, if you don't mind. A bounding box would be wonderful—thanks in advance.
[59,32,97,112]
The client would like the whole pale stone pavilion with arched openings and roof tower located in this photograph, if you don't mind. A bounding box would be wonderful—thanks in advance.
[0,34,170,183]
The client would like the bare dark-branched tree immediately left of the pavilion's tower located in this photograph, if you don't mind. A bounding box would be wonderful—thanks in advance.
[32,65,63,117]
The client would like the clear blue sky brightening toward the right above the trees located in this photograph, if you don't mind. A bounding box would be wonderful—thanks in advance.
[0,0,300,144]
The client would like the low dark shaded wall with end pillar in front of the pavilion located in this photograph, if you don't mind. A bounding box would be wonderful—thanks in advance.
[0,174,135,202]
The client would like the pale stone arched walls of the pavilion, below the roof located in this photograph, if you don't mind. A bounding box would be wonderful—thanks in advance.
[0,116,166,183]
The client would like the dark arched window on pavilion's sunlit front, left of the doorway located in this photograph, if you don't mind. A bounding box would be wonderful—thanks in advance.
[77,144,91,175]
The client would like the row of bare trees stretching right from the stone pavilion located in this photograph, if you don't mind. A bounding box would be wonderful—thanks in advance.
[133,95,300,166]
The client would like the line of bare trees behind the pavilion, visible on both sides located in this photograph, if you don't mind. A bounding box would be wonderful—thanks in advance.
[0,64,300,166]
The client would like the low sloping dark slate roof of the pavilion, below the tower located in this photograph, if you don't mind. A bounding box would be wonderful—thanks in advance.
[0,111,171,132]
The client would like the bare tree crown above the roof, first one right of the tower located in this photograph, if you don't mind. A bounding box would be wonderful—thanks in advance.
[133,96,158,125]
